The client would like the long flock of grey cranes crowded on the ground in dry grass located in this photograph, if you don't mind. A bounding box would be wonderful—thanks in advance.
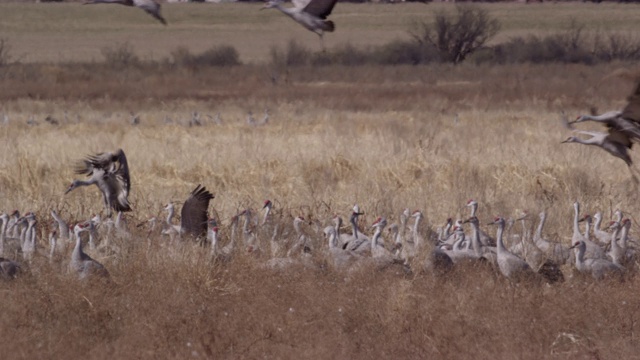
[0,149,637,283]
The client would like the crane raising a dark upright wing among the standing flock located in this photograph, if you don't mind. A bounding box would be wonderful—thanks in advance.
[164,184,214,240]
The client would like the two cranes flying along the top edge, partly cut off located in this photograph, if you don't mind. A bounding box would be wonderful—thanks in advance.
[84,0,338,48]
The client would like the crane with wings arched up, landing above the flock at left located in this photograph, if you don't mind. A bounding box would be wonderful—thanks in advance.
[65,149,131,217]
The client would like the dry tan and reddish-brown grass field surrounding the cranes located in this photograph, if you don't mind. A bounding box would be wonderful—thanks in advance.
[0,3,640,359]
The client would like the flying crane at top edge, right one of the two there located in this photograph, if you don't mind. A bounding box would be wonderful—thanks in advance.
[261,0,338,49]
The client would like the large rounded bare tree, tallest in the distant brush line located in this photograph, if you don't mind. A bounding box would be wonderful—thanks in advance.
[411,5,500,64]
